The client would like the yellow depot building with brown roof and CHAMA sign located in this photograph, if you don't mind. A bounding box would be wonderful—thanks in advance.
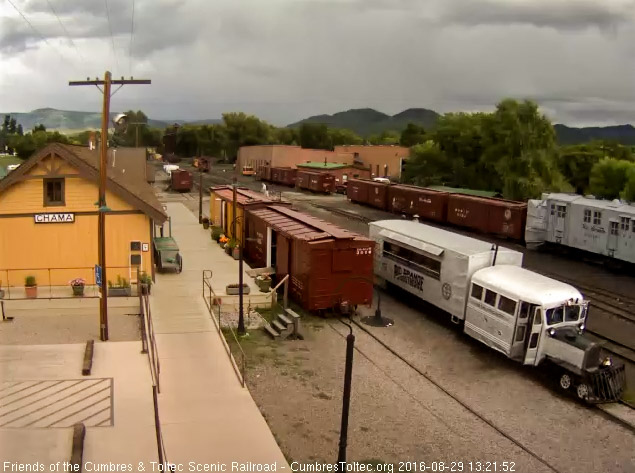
[0,143,167,290]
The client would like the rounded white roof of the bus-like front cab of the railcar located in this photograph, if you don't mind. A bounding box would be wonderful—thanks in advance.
[472,265,582,305]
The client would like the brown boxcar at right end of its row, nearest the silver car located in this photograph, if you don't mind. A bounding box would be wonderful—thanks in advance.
[447,194,527,241]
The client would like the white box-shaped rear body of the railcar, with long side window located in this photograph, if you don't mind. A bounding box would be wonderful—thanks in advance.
[369,220,523,322]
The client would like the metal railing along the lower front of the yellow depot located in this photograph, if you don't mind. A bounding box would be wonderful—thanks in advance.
[0,266,139,300]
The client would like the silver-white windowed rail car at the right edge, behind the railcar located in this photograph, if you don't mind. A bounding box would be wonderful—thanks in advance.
[525,193,635,263]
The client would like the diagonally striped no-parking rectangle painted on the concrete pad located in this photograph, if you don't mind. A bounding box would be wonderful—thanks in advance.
[0,378,113,428]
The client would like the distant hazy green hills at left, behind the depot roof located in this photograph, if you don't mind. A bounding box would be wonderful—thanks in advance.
[0,108,222,132]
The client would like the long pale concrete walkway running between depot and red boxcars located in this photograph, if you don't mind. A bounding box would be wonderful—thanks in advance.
[150,203,288,468]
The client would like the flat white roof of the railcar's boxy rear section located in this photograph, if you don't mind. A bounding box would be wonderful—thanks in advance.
[369,220,513,256]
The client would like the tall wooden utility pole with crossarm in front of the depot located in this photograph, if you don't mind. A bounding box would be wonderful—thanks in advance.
[68,71,151,342]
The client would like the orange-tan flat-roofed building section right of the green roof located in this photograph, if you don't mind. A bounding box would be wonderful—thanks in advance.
[335,145,410,180]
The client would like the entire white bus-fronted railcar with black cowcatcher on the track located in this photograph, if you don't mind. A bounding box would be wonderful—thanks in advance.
[370,220,625,402]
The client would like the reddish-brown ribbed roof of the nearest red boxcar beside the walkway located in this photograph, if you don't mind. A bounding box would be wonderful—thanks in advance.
[249,205,368,241]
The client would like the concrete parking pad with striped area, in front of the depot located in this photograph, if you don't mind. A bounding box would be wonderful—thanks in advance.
[0,342,157,464]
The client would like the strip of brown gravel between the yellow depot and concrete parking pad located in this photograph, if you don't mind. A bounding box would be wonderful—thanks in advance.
[0,312,141,345]
